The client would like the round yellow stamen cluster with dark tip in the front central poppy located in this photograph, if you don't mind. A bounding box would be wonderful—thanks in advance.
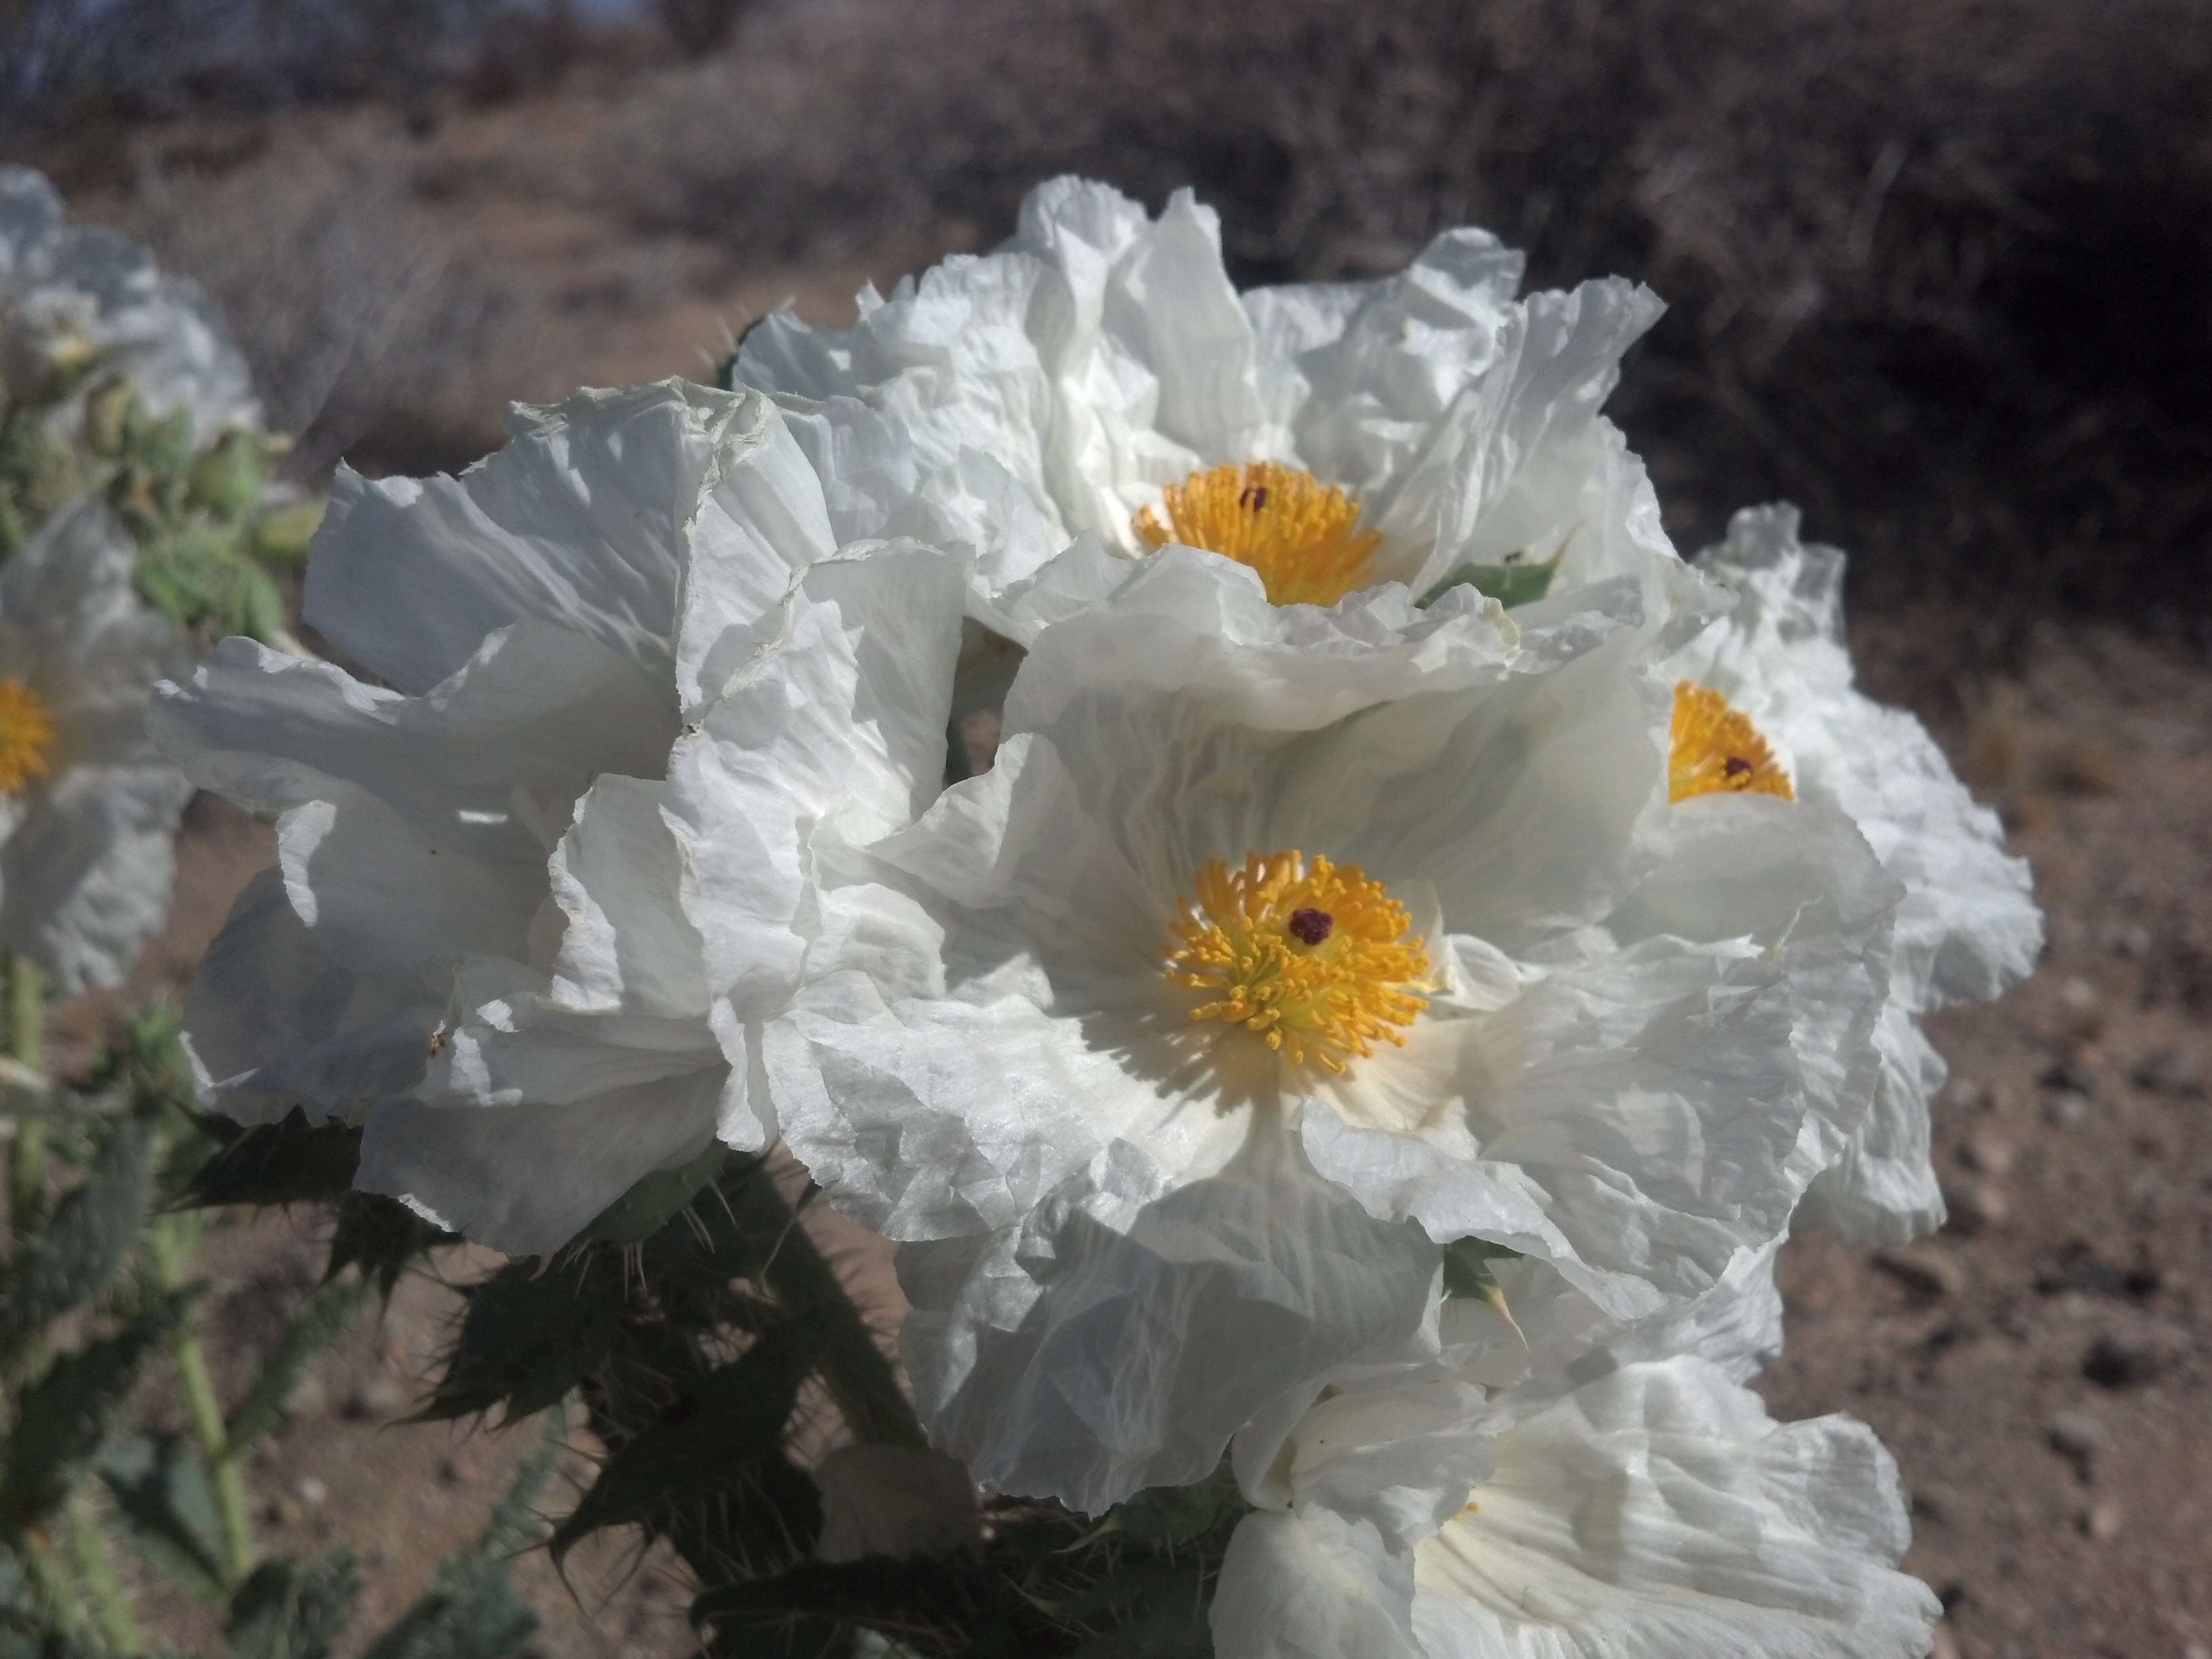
[1168,852,1429,1073]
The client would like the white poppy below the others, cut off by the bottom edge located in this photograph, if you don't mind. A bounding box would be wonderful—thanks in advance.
[1212,1358,1940,1659]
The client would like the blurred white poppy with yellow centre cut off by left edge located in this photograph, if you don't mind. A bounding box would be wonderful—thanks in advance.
[0,502,192,996]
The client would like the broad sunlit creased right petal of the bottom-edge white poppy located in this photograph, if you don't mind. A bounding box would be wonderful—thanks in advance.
[1414,1360,1940,1659]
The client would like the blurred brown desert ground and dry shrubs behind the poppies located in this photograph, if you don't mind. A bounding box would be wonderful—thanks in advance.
[0,0,2212,1659]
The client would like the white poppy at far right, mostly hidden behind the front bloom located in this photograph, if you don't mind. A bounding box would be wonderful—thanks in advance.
[1666,506,2044,1241]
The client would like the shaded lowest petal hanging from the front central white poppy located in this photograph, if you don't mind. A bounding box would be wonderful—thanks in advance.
[900,1124,1438,1513]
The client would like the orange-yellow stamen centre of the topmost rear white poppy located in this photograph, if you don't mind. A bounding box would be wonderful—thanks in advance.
[1132,460,1382,604]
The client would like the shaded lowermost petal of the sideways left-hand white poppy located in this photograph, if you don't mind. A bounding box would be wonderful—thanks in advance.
[354,1071,721,1256]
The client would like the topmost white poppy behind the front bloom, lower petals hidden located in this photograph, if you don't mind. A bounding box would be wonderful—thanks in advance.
[730,179,1694,644]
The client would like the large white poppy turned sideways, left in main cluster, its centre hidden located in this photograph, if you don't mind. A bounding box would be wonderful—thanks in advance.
[161,380,966,1252]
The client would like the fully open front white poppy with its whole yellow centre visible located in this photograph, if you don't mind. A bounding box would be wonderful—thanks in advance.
[765,548,1896,1509]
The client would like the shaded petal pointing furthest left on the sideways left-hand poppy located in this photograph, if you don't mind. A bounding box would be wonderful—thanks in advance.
[150,621,675,971]
